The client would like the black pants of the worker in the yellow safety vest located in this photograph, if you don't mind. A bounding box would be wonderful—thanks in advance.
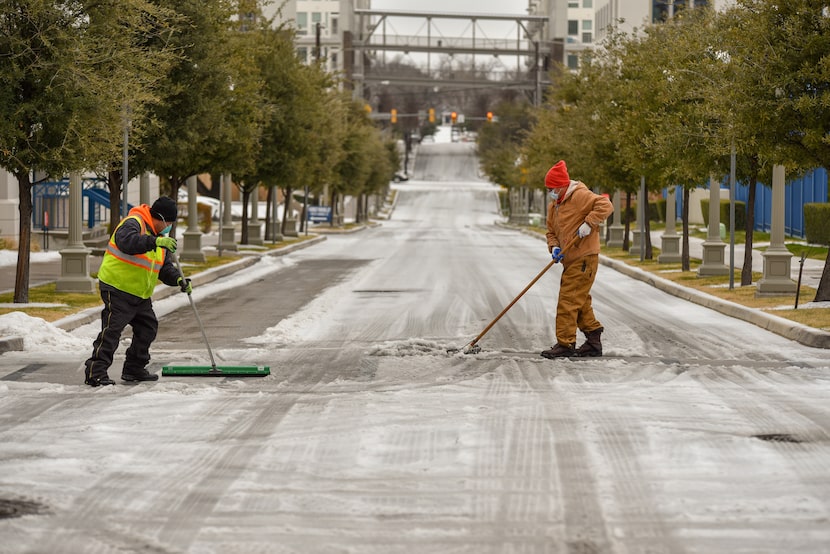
[86,283,158,378]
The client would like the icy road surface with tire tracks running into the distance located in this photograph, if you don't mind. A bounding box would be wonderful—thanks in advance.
[0,143,830,554]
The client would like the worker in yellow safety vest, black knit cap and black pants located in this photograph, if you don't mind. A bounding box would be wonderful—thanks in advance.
[85,196,193,387]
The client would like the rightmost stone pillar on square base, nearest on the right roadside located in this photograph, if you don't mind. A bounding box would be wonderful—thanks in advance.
[755,165,796,296]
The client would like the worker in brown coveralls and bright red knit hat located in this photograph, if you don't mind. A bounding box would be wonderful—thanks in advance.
[542,160,614,359]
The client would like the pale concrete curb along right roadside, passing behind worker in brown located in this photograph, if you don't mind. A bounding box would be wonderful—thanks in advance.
[496,222,830,348]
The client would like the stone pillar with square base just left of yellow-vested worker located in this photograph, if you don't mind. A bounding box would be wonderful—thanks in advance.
[55,172,97,294]
